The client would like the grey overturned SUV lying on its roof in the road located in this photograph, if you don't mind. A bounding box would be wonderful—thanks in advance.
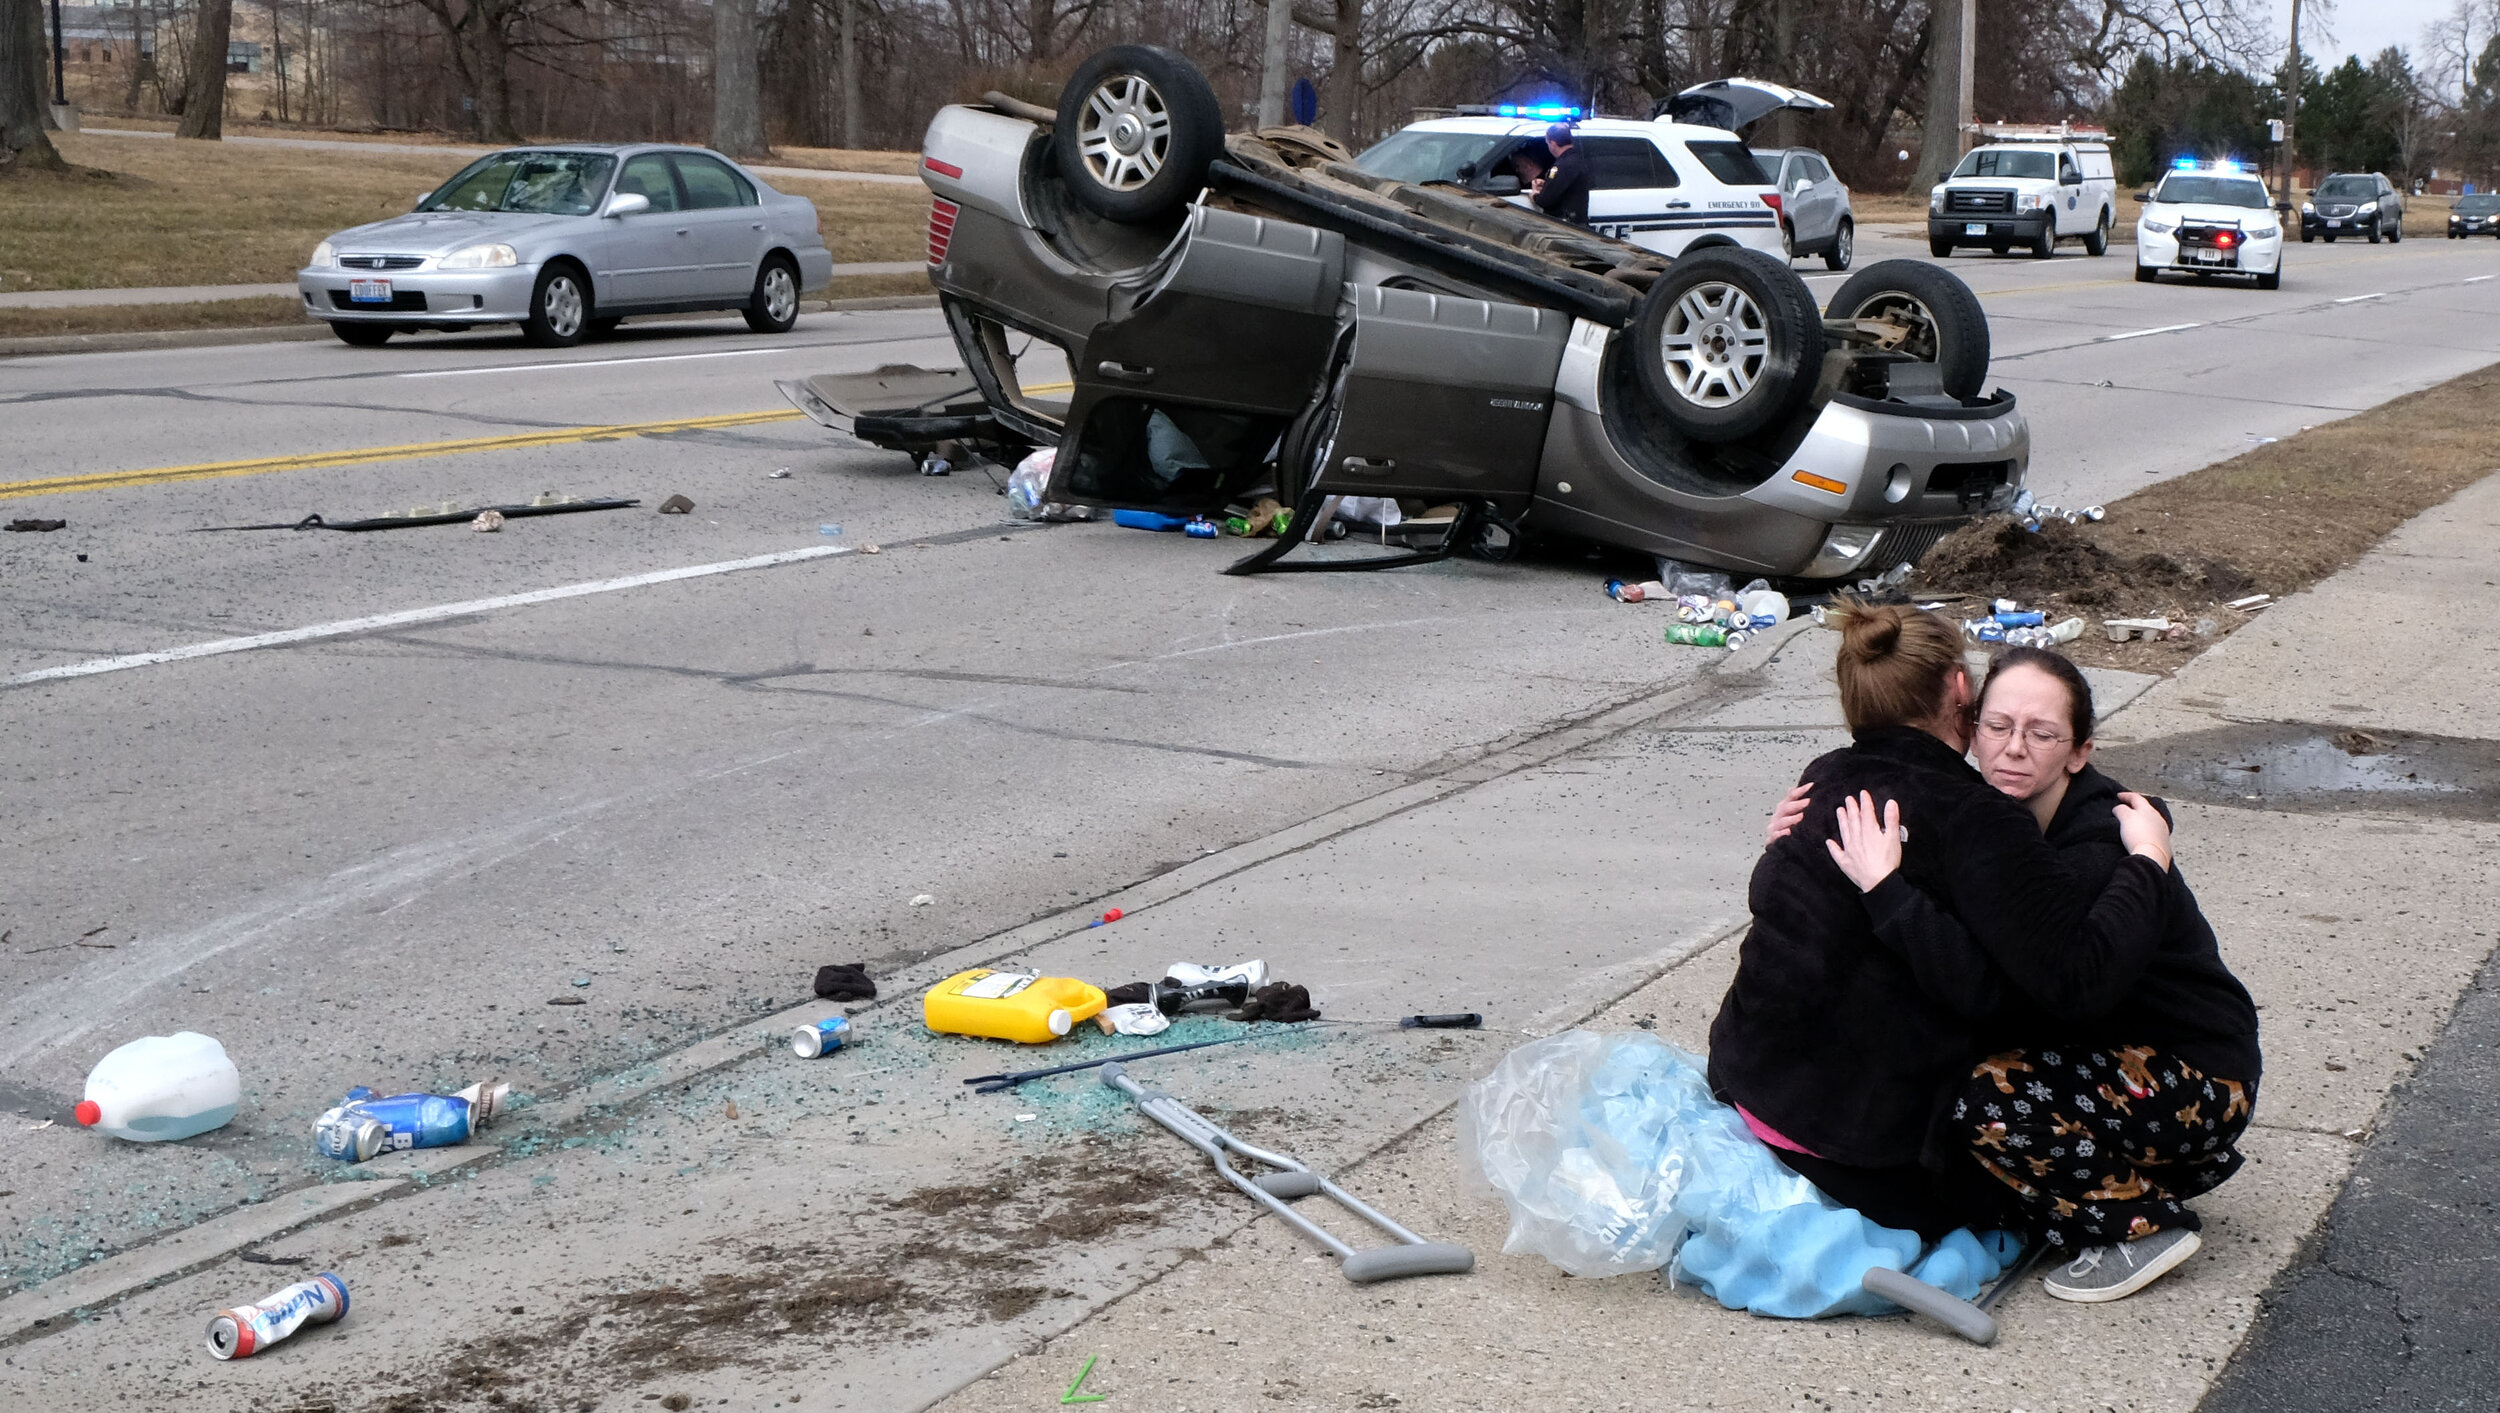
[810,45,2030,580]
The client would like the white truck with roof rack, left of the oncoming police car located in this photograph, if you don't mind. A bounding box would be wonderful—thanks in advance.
[1928,140,2118,260]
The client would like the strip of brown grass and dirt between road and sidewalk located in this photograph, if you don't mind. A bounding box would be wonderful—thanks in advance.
[1910,368,2500,673]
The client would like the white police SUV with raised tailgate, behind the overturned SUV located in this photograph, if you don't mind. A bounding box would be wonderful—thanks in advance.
[1355,78,1830,260]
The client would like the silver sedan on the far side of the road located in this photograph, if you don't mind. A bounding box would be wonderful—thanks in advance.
[295,143,833,348]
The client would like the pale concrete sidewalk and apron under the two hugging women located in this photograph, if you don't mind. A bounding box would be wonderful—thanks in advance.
[0,480,2500,1413]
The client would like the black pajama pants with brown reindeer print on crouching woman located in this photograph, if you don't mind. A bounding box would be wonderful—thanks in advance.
[1953,1045,2258,1250]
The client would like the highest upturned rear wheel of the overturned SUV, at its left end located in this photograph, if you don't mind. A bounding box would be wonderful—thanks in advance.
[1053,45,1225,225]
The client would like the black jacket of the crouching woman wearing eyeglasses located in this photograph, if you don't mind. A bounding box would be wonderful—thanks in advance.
[1868,765,2260,1088]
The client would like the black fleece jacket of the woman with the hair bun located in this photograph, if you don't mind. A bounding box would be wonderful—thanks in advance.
[1710,728,2168,1168]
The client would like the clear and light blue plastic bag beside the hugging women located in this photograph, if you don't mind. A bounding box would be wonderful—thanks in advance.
[1458,1030,2018,1318]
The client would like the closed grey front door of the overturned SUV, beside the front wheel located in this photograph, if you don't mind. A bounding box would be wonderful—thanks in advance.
[1313,285,1573,515]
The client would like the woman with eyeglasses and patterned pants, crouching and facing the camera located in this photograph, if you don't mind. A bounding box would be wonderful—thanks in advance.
[1773,648,2260,1300]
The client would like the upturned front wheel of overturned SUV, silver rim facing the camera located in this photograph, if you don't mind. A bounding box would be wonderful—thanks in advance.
[1633,248,1830,443]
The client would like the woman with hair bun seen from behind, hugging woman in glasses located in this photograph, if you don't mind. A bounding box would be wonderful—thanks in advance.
[1710,605,2170,1240]
